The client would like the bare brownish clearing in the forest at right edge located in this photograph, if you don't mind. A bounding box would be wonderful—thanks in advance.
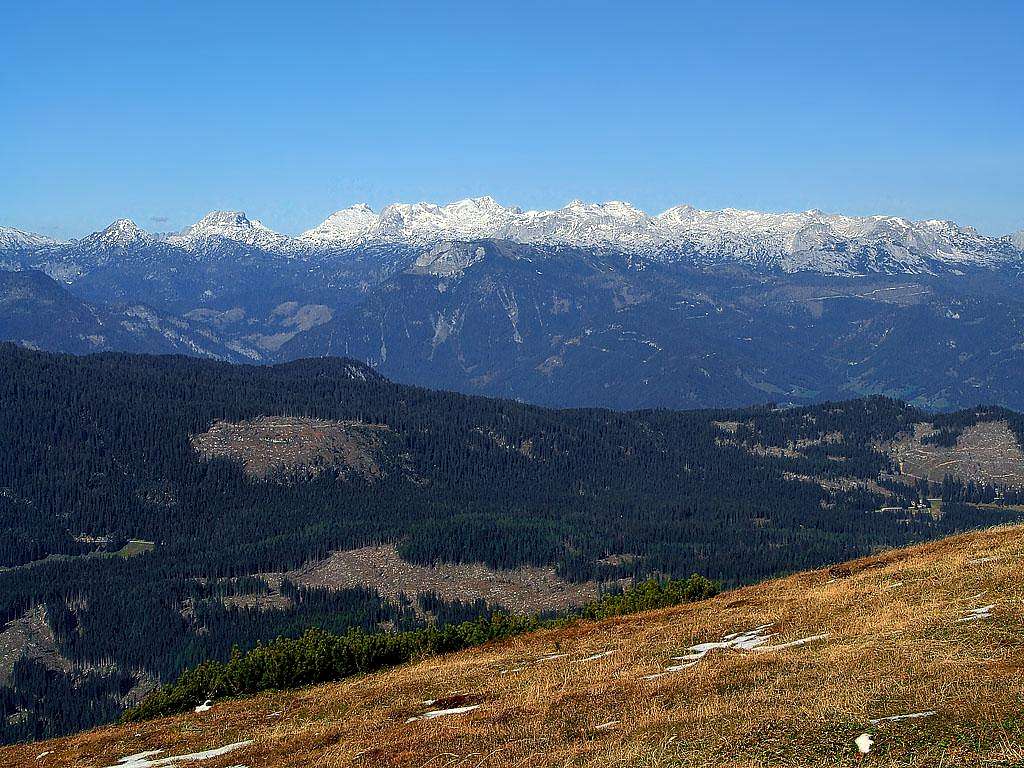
[889,421,1024,485]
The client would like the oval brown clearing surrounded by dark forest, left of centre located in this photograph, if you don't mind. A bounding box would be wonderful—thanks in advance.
[191,416,391,479]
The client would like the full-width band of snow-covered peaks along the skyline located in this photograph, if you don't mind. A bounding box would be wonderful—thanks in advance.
[0,197,1024,274]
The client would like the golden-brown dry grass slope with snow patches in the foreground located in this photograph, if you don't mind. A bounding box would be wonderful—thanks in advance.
[9,527,1024,768]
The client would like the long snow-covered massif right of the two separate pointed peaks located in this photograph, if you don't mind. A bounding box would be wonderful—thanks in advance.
[295,198,1020,273]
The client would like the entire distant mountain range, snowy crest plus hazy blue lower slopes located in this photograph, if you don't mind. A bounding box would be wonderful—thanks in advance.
[0,198,1024,409]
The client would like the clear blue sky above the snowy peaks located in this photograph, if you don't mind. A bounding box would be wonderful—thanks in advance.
[0,0,1024,237]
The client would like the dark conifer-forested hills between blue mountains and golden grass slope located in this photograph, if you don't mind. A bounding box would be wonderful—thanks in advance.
[0,345,1022,740]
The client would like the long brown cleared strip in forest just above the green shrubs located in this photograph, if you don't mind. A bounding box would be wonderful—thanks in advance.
[272,545,598,613]
